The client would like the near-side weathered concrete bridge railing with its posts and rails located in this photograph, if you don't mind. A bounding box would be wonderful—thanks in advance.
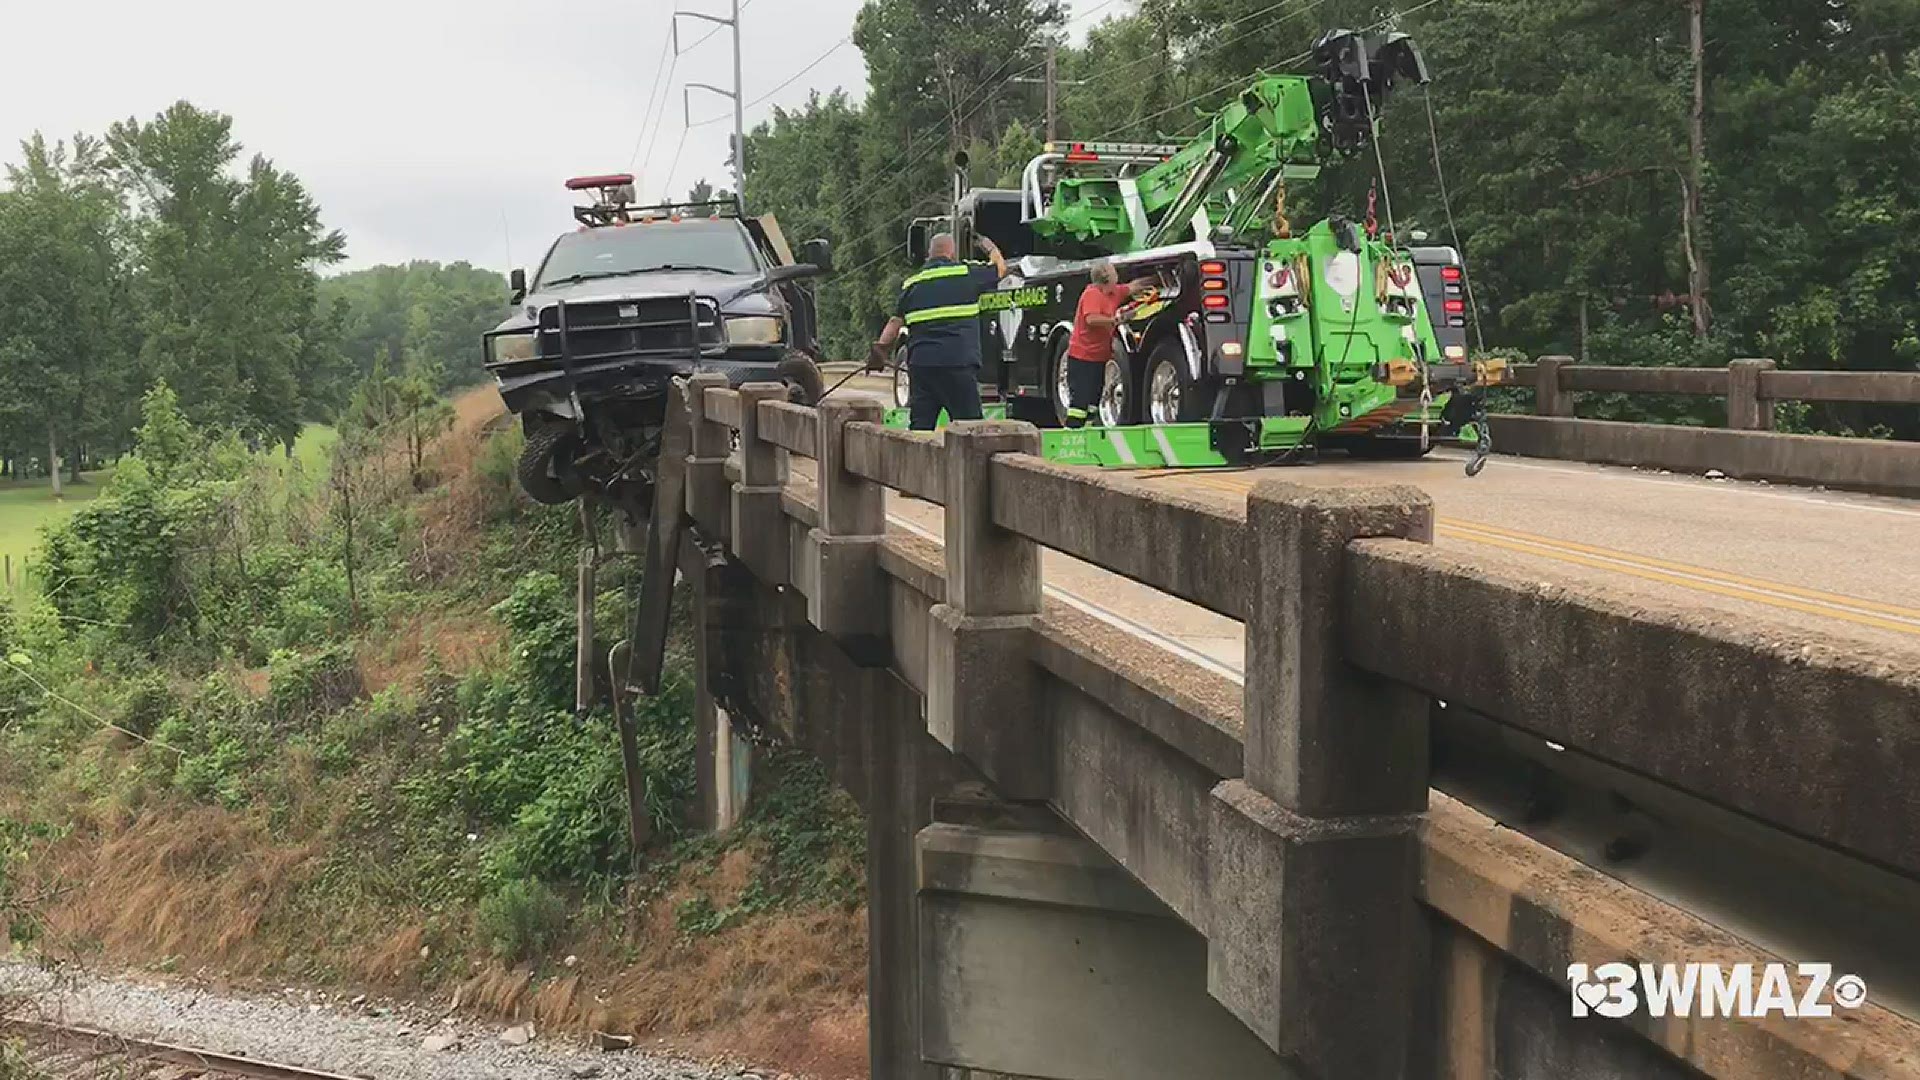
[687,377,1920,1076]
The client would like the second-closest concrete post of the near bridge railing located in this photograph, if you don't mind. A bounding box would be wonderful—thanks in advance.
[927,421,1054,799]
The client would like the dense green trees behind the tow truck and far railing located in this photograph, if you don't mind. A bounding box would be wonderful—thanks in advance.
[747,0,1920,438]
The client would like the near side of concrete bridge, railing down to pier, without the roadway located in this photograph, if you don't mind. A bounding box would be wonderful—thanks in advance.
[649,367,1920,1080]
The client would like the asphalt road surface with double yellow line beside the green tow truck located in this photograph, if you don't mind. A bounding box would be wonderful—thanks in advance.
[1137,452,1920,655]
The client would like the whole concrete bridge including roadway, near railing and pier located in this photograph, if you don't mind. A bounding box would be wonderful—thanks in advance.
[636,365,1920,1080]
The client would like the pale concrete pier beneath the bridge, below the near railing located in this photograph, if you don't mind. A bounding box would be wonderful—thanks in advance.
[910,822,1296,1080]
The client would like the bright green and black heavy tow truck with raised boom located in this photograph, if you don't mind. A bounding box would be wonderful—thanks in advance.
[889,31,1505,466]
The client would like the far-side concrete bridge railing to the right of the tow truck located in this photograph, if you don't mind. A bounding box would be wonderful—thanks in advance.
[1494,356,1920,496]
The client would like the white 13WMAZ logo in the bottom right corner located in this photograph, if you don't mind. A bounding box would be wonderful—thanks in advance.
[1567,961,1866,1020]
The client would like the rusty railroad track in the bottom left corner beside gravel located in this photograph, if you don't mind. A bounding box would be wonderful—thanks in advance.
[0,1020,363,1080]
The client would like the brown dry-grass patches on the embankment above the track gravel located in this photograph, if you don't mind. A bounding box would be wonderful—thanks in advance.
[0,388,866,1080]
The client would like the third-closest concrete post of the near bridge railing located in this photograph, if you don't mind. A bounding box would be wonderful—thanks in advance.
[806,400,893,667]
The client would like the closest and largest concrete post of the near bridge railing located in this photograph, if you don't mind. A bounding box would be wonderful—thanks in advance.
[1206,482,1432,1080]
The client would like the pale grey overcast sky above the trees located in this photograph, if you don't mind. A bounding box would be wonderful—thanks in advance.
[0,0,1121,269]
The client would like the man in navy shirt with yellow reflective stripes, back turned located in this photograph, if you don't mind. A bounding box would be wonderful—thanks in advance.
[876,233,1006,430]
